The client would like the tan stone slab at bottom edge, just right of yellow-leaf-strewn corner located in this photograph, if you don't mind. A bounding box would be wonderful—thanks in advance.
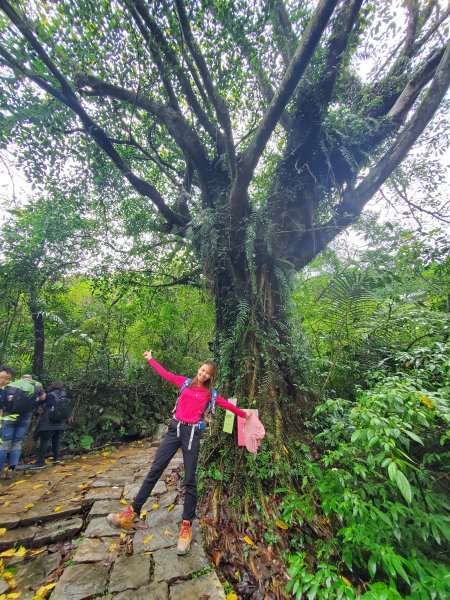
[51,564,109,600]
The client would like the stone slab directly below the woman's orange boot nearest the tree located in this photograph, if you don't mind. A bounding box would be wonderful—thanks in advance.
[152,544,209,583]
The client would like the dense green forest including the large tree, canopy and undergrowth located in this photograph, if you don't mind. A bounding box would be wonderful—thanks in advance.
[0,0,450,600]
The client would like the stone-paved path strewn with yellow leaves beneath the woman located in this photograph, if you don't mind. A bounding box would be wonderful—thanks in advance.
[0,434,225,600]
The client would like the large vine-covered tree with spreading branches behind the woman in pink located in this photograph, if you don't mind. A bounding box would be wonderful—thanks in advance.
[0,0,450,472]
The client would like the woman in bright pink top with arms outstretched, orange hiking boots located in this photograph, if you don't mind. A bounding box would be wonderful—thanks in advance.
[107,350,252,555]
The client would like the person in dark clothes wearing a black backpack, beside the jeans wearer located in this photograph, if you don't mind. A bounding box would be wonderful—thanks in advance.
[30,379,69,470]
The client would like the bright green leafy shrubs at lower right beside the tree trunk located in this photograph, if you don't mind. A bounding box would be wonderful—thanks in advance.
[280,342,450,599]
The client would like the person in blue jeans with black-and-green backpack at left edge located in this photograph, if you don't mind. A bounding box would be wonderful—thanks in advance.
[0,375,45,477]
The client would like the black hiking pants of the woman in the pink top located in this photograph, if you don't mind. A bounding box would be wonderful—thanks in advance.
[133,419,201,523]
